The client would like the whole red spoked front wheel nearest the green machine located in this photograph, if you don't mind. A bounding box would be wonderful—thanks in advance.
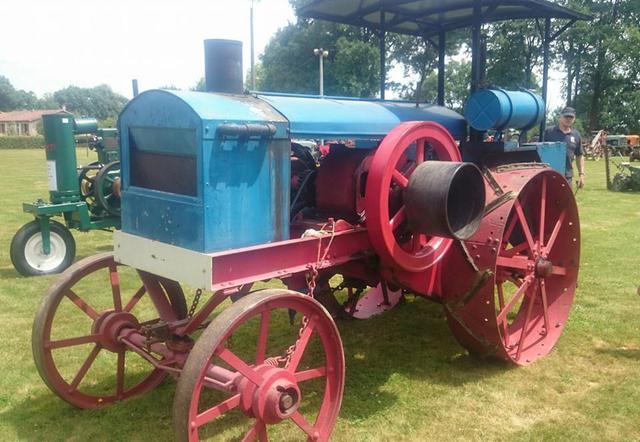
[32,252,187,408]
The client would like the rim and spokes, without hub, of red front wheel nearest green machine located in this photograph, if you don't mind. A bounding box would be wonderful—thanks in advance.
[32,252,182,408]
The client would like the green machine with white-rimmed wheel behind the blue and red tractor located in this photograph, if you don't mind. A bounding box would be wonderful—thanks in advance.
[10,113,120,276]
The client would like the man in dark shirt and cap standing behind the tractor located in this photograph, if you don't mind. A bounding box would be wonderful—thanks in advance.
[544,106,584,188]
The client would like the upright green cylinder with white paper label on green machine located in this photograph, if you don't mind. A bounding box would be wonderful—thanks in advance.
[42,113,80,204]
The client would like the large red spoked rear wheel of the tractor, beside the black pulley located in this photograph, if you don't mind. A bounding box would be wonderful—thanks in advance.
[494,171,580,365]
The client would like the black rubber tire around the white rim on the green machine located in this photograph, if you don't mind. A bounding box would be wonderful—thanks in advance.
[9,220,76,276]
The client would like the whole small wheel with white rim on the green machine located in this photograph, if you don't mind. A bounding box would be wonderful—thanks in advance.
[11,220,76,276]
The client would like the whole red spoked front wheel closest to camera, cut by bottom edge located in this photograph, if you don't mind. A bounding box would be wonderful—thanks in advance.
[173,289,345,441]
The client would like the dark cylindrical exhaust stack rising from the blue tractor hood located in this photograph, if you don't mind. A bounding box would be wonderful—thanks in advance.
[204,39,244,94]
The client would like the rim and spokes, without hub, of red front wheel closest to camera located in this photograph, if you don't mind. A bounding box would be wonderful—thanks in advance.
[174,290,344,441]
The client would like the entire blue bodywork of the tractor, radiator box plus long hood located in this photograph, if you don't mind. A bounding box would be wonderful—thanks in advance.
[118,90,466,253]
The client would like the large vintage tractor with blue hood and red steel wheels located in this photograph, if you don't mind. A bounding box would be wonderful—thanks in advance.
[33,40,580,441]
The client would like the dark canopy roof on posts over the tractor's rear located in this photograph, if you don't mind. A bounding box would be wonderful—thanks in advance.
[297,0,590,37]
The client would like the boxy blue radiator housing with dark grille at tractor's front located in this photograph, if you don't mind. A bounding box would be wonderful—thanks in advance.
[118,90,290,253]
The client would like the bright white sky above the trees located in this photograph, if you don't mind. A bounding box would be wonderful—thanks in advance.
[0,0,562,109]
